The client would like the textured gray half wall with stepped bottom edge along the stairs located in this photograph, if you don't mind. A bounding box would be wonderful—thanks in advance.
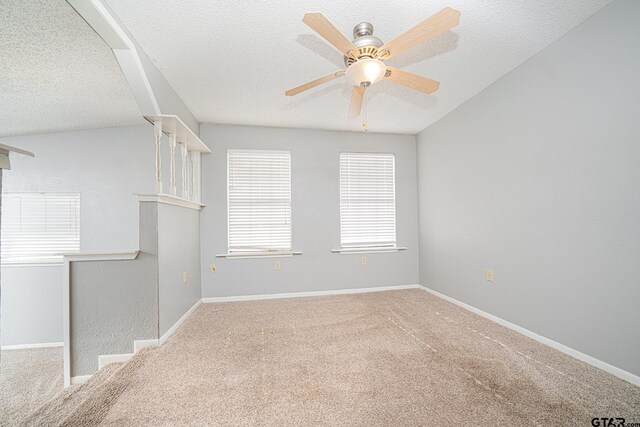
[70,202,159,377]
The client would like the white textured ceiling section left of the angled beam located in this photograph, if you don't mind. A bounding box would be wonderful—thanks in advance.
[0,0,143,136]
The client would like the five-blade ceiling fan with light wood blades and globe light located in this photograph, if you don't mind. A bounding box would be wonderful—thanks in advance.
[285,7,460,118]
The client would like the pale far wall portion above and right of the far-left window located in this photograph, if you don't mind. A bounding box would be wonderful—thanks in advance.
[0,125,157,251]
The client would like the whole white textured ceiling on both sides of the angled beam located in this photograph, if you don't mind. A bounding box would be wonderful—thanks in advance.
[0,0,611,135]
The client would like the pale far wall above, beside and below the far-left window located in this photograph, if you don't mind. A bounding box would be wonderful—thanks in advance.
[0,125,155,345]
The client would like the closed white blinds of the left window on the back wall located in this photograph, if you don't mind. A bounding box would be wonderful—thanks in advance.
[227,150,291,253]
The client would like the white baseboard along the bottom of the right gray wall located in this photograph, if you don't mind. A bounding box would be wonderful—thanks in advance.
[419,286,640,386]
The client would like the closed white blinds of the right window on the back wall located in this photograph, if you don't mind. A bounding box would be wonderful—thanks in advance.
[340,153,396,248]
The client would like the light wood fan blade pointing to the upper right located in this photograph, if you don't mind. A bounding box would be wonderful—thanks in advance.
[379,7,460,59]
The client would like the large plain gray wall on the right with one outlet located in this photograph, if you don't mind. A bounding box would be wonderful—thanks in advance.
[418,0,640,375]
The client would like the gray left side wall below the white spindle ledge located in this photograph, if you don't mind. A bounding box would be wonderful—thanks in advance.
[158,203,202,337]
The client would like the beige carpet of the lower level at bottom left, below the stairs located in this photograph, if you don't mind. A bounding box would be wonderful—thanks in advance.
[0,347,63,426]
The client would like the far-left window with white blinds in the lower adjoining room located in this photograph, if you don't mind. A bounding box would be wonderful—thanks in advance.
[2,193,80,264]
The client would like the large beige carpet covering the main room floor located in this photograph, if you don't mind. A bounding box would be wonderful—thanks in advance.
[20,290,640,426]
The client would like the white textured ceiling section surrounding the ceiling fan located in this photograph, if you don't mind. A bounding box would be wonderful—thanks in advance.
[107,0,611,133]
